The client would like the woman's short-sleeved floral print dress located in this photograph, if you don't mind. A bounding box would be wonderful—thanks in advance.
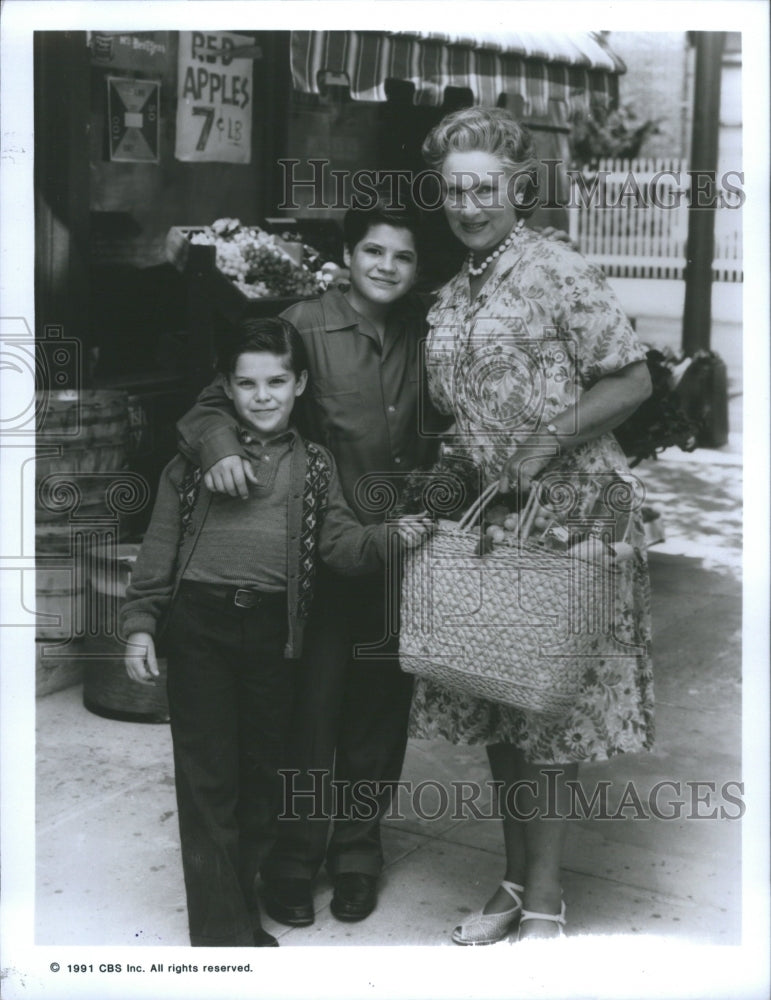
[410,229,653,764]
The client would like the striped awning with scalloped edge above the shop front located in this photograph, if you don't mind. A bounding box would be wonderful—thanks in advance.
[291,31,626,115]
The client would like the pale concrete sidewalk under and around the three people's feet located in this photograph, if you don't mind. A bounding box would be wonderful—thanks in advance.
[35,441,742,951]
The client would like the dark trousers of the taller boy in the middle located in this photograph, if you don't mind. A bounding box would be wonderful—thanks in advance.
[262,571,413,879]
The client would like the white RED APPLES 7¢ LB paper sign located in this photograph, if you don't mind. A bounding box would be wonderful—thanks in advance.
[175,31,253,163]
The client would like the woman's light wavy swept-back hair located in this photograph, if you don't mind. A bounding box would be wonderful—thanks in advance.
[422,108,538,215]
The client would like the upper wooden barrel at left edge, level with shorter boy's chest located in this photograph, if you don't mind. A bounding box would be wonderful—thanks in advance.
[35,389,128,553]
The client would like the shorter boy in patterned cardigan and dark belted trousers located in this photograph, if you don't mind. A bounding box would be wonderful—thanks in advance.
[121,319,432,947]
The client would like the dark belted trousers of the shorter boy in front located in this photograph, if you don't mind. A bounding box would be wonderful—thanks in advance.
[166,583,297,947]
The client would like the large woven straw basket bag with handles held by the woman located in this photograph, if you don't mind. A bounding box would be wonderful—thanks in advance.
[399,487,624,718]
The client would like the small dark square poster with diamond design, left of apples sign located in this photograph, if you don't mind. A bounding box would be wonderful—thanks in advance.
[107,76,161,163]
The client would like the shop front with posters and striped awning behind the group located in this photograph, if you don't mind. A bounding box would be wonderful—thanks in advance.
[35,30,624,516]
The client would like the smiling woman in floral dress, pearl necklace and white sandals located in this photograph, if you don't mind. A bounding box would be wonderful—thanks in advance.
[411,108,653,944]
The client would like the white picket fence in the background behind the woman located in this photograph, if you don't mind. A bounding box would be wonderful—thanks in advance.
[568,158,743,281]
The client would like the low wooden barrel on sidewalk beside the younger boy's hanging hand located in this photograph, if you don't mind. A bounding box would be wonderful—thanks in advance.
[83,544,169,722]
